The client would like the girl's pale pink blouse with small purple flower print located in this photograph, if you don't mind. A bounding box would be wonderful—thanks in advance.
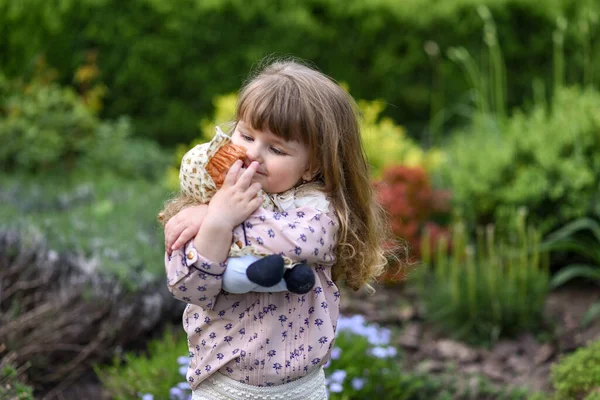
[165,206,340,389]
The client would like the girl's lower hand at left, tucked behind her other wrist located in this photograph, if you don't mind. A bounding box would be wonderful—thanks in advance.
[165,204,208,255]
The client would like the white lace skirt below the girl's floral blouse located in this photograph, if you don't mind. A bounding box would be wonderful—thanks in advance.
[192,368,327,400]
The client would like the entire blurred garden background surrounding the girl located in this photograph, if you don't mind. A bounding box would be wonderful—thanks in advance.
[0,0,600,400]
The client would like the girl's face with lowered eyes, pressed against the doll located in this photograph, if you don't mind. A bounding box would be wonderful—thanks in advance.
[231,121,313,193]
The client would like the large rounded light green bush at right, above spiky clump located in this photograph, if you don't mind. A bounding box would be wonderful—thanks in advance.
[439,88,600,232]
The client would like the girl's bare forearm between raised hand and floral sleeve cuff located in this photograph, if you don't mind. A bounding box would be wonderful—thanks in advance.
[194,216,233,262]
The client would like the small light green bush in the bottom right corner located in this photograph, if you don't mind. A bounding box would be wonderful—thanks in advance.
[551,341,600,400]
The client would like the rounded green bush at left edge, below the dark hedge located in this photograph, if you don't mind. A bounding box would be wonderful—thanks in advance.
[0,71,166,179]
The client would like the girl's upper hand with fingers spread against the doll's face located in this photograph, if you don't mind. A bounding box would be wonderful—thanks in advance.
[206,160,263,230]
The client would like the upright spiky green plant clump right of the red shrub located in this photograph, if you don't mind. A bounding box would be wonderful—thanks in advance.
[417,211,549,344]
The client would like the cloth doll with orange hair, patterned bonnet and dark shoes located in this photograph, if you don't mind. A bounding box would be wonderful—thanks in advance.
[168,127,315,294]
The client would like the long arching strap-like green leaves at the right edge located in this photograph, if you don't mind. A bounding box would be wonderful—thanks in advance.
[542,218,600,326]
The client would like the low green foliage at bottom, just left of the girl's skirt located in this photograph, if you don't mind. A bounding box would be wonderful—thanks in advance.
[94,328,187,400]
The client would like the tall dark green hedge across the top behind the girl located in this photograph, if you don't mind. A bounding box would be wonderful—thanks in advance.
[0,0,600,144]
